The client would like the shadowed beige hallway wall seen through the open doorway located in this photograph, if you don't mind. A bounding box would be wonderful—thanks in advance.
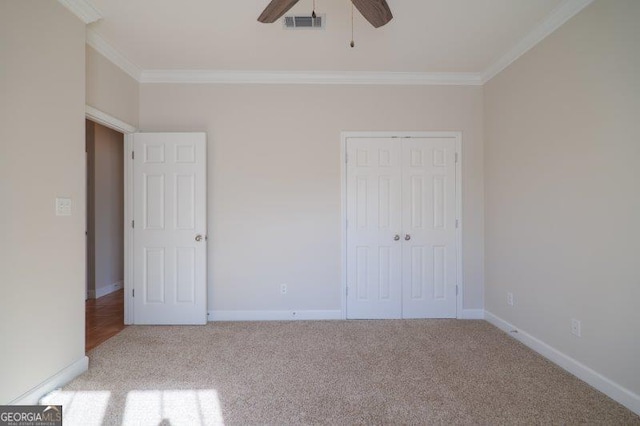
[87,120,124,297]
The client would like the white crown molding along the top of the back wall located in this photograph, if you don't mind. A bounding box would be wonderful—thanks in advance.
[140,70,482,86]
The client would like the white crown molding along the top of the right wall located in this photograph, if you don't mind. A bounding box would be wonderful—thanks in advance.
[482,0,594,84]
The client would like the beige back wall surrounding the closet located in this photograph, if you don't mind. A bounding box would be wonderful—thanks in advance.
[140,84,484,310]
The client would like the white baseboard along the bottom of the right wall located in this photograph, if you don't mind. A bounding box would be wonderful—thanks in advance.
[485,311,640,414]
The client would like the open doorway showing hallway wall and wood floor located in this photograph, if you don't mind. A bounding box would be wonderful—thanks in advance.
[85,120,125,351]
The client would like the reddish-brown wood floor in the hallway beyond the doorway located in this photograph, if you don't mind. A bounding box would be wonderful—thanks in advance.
[85,290,125,352]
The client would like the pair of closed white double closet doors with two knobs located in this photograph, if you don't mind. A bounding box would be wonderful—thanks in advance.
[346,137,457,319]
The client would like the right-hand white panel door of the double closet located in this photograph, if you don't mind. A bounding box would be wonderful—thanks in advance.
[402,138,457,318]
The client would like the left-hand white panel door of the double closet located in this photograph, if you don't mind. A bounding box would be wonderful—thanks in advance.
[346,138,403,319]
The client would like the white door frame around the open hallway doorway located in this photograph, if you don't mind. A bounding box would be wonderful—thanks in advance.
[85,105,138,324]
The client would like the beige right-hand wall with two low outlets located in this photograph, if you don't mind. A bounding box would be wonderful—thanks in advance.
[485,0,640,394]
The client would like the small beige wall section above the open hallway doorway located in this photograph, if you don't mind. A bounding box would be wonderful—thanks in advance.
[86,45,140,127]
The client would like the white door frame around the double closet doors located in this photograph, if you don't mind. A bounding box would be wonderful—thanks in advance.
[340,131,464,319]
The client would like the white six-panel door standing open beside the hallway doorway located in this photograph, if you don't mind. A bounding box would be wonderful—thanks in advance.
[133,133,207,324]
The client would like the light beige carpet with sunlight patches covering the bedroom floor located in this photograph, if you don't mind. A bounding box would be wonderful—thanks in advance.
[48,320,640,425]
